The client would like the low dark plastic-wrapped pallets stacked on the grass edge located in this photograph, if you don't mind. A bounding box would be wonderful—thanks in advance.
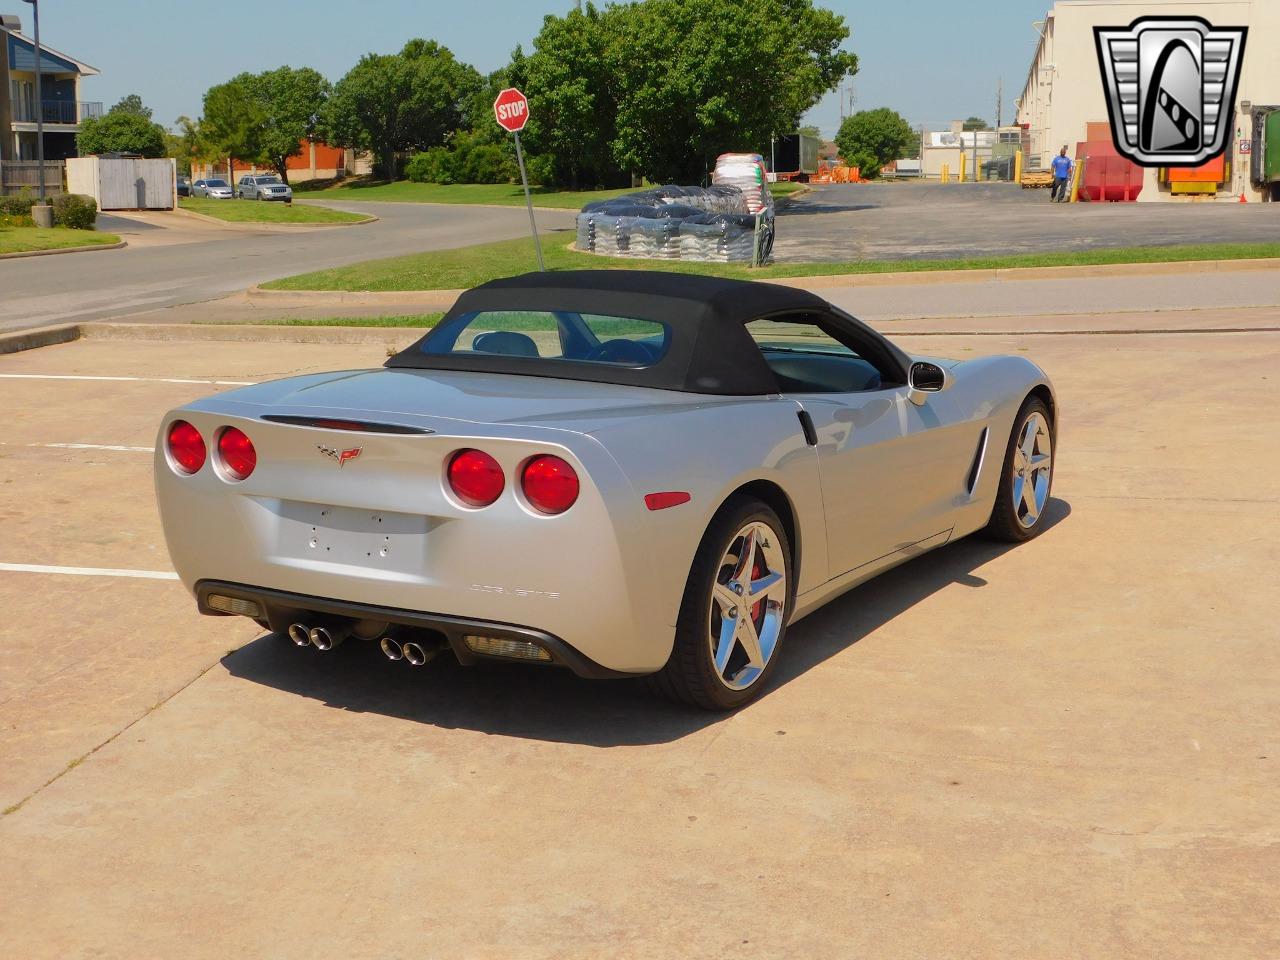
[577,178,773,262]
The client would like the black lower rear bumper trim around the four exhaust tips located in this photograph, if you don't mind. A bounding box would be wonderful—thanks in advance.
[195,580,635,680]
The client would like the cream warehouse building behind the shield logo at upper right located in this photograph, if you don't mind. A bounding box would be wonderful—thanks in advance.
[1018,0,1280,202]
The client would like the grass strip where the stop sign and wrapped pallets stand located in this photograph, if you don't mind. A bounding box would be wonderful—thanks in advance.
[262,233,1280,291]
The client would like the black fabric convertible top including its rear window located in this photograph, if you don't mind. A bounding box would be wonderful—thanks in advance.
[387,270,908,397]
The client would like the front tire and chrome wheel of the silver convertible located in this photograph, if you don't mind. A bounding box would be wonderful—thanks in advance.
[987,397,1056,543]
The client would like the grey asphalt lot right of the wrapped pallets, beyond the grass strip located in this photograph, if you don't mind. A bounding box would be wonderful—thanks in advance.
[773,183,1280,261]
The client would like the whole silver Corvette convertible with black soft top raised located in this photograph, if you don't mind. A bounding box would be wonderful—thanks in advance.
[155,270,1056,709]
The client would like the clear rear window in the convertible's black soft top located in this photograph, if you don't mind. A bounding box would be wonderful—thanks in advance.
[421,310,669,367]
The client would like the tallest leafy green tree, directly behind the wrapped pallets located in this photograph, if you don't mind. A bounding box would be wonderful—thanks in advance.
[609,0,858,182]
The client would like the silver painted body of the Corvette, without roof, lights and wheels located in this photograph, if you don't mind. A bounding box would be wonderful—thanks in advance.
[155,348,1051,673]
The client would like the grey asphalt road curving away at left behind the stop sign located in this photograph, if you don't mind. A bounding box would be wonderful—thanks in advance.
[0,204,573,330]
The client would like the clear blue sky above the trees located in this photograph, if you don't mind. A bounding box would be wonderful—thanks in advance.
[27,0,1050,133]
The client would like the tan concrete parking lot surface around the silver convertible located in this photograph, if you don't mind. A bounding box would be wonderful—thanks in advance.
[0,310,1280,960]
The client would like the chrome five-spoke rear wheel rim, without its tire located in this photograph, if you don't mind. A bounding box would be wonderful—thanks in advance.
[708,521,787,690]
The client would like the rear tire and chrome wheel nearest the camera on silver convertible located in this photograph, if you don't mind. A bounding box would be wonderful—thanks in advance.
[648,497,795,710]
